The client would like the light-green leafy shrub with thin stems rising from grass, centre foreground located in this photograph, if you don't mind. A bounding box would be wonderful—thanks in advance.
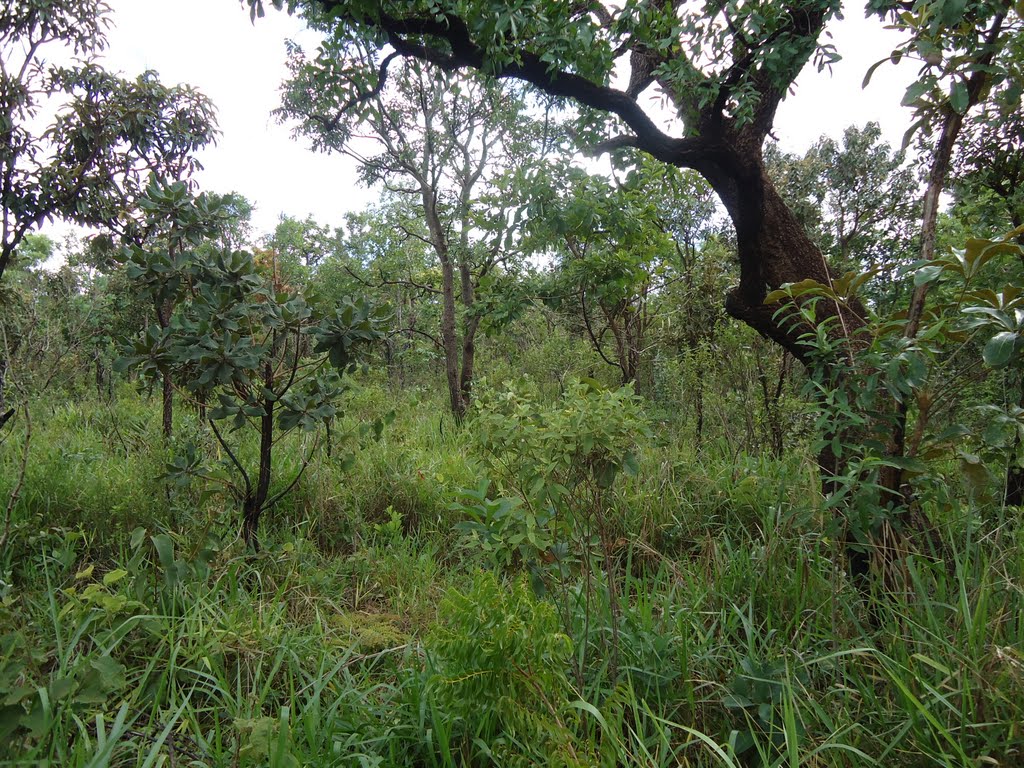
[453,379,650,669]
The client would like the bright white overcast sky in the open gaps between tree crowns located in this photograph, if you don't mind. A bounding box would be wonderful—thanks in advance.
[44,0,912,240]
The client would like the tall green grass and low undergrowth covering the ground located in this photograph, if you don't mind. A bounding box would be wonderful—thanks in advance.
[0,383,1024,768]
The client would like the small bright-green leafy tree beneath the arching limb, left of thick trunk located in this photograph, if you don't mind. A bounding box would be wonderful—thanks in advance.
[524,156,714,384]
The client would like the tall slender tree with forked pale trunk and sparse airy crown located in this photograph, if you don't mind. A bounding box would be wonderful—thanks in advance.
[281,49,522,421]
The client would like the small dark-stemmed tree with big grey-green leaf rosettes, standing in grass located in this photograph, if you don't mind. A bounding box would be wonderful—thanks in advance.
[117,185,384,542]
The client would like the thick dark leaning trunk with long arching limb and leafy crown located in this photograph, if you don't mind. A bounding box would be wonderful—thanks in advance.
[248,0,862,356]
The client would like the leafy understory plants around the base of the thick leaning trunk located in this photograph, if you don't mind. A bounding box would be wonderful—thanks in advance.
[766,229,1024,589]
